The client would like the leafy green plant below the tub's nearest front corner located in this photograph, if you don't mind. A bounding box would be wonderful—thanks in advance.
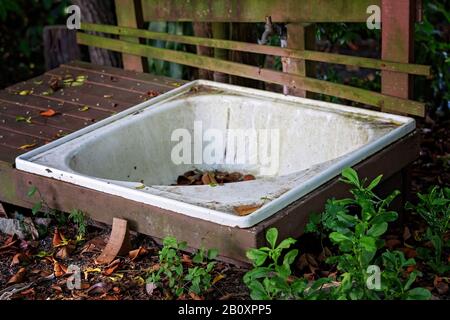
[244,228,331,300]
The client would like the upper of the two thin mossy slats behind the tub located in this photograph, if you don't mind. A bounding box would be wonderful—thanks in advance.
[81,23,430,76]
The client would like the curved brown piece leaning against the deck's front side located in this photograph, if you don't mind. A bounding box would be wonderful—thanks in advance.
[95,218,131,264]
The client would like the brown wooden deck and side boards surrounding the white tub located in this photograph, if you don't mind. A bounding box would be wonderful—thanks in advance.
[0,62,419,261]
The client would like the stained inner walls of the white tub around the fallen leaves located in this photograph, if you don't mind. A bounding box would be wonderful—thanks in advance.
[68,92,395,186]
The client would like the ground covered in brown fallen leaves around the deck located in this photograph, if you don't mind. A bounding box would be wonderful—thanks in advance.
[0,112,450,300]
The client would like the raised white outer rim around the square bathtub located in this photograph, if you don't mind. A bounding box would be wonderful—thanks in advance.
[15,80,415,228]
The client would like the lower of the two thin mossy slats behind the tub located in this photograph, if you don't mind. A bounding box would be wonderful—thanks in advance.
[77,33,425,116]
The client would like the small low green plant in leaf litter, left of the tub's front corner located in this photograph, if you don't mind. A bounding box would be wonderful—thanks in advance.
[147,237,218,297]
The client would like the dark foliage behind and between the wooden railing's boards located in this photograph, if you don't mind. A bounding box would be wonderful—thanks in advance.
[0,0,450,113]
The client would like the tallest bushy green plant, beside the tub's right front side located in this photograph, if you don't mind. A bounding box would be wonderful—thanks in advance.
[306,168,430,300]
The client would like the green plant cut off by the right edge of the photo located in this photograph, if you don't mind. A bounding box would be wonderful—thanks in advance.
[406,186,450,274]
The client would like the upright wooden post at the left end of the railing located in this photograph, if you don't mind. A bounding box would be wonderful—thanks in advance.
[115,0,146,72]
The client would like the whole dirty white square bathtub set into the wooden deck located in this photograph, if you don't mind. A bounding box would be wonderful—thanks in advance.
[16,80,415,228]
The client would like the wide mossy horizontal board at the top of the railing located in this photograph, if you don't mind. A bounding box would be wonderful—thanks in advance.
[142,0,380,23]
